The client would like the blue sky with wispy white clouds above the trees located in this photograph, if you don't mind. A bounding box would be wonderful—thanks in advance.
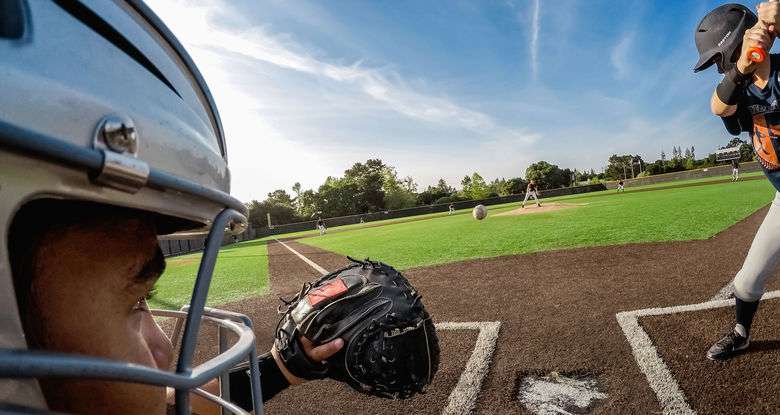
[148,0,740,201]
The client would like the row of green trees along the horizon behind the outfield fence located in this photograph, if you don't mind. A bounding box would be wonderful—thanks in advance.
[247,138,753,228]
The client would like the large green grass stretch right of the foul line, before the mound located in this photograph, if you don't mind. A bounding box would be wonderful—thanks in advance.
[299,180,774,269]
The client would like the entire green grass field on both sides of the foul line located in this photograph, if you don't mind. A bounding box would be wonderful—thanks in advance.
[150,176,774,308]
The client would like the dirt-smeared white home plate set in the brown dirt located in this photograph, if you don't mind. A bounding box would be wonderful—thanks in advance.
[517,372,607,415]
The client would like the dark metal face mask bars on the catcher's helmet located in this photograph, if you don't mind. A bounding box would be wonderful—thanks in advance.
[0,121,263,415]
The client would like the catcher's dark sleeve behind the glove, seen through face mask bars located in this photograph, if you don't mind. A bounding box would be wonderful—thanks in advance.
[230,353,290,411]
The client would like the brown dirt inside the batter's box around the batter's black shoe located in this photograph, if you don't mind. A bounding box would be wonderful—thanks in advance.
[639,299,780,414]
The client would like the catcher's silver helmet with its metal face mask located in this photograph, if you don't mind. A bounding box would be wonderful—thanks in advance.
[0,0,261,414]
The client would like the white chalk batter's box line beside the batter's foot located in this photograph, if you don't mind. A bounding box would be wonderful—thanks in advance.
[615,290,780,415]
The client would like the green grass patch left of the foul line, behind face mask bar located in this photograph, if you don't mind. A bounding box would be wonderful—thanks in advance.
[149,241,268,309]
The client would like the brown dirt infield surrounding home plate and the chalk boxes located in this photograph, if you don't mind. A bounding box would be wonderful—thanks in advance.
[166,208,780,414]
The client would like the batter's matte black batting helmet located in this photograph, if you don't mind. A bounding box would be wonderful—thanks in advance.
[693,4,758,73]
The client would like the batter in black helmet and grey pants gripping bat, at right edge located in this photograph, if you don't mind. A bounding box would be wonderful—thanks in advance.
[694,2,780,360]
